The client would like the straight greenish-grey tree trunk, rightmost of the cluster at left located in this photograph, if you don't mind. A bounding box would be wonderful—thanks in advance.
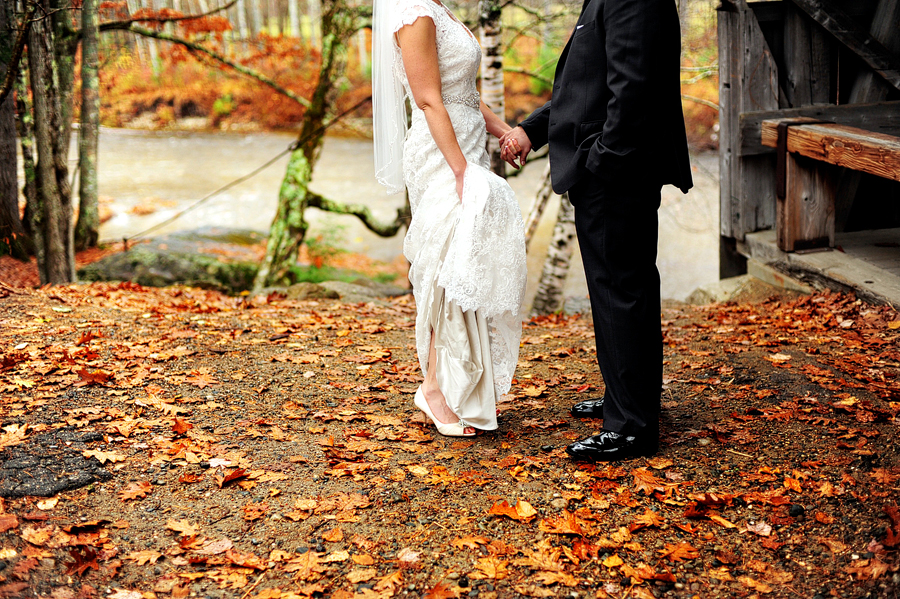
[75,0,100,250]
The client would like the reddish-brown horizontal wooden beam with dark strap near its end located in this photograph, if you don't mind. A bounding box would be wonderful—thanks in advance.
[762,120,900,181]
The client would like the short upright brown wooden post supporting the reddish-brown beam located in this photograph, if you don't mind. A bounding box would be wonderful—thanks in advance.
[775,155,837,252]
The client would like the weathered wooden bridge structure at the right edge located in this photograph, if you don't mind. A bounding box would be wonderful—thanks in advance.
[718,0,900,305]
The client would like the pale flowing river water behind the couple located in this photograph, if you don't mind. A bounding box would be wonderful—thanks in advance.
[86,128,719,299]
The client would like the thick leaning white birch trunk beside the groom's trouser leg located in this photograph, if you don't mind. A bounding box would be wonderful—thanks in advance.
[531,194,576,314]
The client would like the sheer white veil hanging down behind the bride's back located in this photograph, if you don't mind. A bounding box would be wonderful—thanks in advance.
[372,0,406,193]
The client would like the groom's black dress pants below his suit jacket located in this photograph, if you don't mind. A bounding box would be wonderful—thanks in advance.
[569,174,662,438]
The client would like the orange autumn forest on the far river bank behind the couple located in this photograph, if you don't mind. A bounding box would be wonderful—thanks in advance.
[100,0,718,145]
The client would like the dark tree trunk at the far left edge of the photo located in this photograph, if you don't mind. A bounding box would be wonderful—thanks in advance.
[0,2,29,260]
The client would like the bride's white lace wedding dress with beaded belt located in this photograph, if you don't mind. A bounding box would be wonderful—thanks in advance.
[392,0,526,430]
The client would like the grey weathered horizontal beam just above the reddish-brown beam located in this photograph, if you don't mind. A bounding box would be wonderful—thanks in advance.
[740,99,900,156]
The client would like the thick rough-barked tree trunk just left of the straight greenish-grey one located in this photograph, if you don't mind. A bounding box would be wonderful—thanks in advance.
[28,3,75,284]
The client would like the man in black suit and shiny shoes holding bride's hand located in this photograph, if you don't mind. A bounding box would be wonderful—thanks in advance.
[501,0,693,461]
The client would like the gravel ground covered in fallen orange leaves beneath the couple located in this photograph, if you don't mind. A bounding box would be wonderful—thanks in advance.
[0,284,900,599]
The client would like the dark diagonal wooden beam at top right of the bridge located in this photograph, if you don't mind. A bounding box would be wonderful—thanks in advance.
[792,0,900,89]
